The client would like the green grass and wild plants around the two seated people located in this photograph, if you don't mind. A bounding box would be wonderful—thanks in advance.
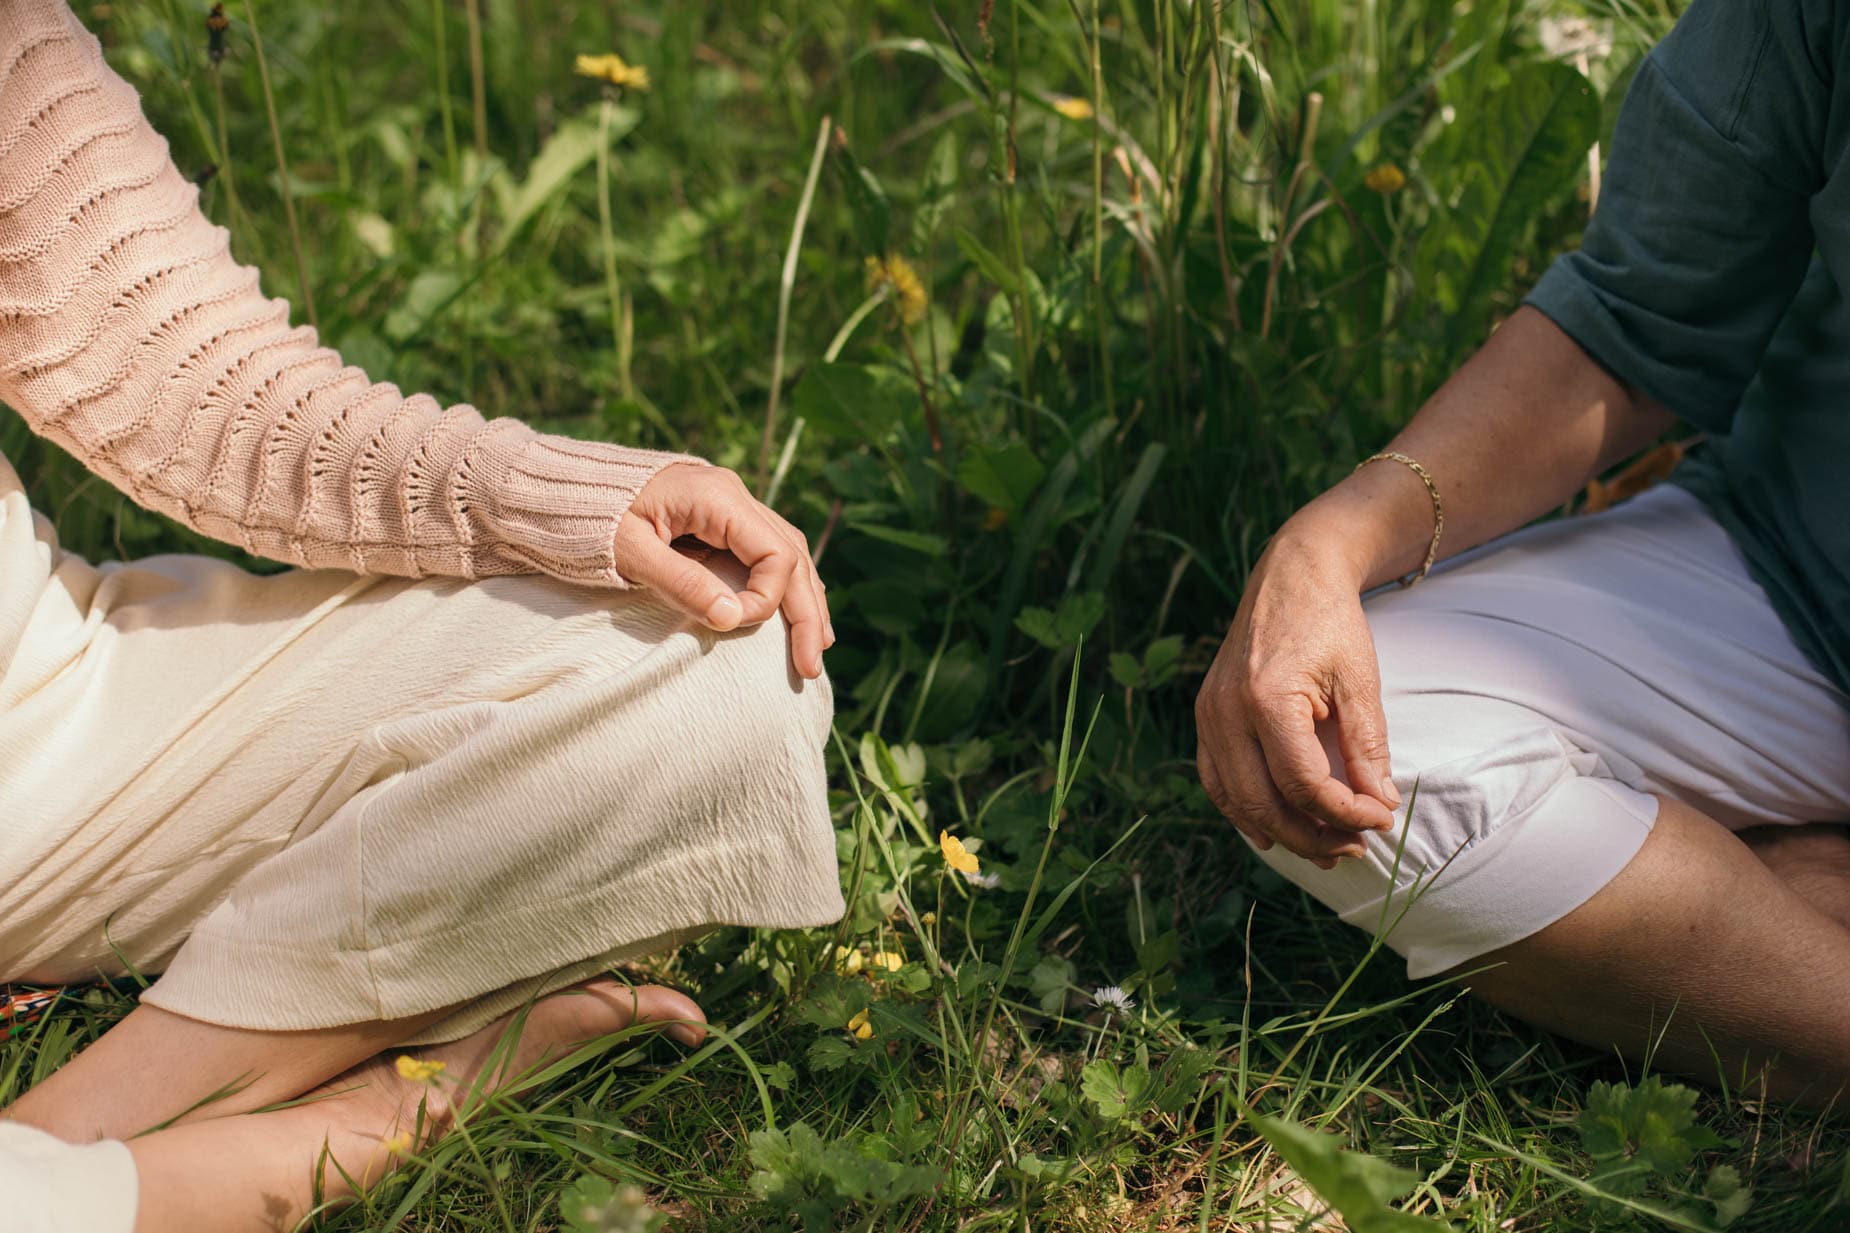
[0,0,1850,1233]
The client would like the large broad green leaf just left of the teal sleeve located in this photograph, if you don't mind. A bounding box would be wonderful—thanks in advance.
[1417,61,1600,354]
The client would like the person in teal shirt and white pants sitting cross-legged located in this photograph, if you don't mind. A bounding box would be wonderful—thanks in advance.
[1197,0,1850,1103]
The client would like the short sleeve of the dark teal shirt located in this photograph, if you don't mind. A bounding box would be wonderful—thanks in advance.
[1526,0,1837,431]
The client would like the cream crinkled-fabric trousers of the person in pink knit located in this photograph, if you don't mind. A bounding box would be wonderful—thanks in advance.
[0,459,842,1233]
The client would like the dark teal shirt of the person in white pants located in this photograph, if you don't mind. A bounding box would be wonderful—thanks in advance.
[1528,0,1850,691]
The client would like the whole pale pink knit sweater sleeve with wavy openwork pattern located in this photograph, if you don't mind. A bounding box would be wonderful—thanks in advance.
[0,0,697,587]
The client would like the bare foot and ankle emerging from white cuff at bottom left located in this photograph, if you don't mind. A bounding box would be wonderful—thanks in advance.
[130,981,701,1233]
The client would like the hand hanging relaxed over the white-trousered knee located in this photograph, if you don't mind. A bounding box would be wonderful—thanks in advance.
[1195,524,1400,868]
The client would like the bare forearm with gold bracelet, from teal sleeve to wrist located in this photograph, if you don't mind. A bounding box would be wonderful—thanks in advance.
[1280,307,1672,587]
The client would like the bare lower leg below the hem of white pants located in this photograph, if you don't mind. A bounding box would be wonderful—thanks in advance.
[1467,800,1850,1105]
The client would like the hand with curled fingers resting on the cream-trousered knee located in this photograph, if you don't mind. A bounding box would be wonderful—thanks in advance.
[616,463,834,679]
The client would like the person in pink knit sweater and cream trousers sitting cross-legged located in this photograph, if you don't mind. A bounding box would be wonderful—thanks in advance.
[0,0,842,1233]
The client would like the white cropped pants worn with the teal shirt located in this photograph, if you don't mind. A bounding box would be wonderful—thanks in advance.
[1262,485,1850,979]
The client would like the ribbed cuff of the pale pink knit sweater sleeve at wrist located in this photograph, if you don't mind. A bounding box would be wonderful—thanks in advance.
[464,420,707,587]
